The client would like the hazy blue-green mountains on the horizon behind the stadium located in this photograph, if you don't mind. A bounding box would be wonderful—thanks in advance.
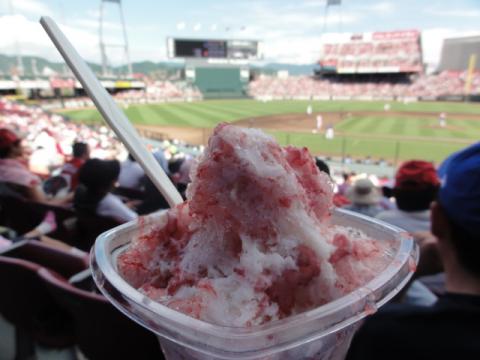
[0,54,315,79]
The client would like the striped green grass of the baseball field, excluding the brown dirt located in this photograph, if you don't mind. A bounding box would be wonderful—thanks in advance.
[60,100,480,161]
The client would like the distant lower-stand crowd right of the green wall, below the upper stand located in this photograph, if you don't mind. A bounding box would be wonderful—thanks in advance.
[249,71,480,99]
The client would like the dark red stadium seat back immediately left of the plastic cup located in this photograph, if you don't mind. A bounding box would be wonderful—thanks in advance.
[39,270,163,360]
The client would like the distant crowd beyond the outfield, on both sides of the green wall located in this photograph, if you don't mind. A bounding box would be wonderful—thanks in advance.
[31,71,480,109]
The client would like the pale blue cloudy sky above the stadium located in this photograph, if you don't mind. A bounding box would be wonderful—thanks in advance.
[0,0,480,65]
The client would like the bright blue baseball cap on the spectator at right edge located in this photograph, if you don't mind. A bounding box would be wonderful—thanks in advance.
[438,142,480,235]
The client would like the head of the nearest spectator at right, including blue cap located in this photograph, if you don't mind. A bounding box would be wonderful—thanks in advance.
[432,143,480,278]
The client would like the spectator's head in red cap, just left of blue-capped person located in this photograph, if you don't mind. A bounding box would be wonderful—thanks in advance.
[393,160,440,212]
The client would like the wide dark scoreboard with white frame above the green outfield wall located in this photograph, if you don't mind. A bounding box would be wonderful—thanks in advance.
[167,38,262,60]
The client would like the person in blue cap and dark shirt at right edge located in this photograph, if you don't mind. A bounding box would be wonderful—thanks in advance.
[347,143,480,360]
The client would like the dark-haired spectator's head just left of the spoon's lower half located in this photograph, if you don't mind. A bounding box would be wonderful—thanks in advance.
[78,159,120,195]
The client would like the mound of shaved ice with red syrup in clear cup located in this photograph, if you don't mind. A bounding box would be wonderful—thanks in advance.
[117,124,392,327]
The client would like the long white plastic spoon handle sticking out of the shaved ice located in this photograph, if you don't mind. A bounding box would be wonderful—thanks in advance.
[40,16,183,208]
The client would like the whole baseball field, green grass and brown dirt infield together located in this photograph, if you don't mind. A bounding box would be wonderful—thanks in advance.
[62,100,480,162]
